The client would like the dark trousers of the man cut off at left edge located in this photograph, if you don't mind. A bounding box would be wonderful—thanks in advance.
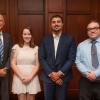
[0,75,9,100]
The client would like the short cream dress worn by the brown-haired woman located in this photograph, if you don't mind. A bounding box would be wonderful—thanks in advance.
[12,44,41,94]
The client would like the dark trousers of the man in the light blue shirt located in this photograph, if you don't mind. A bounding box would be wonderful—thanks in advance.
[79,77,100,100]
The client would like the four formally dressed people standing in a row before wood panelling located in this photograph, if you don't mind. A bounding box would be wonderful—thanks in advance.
[0,14,100,100]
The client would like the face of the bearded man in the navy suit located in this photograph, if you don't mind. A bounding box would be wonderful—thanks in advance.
[51,17,63,33]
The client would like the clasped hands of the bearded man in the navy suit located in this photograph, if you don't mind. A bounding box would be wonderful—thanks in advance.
[49,71,64,85]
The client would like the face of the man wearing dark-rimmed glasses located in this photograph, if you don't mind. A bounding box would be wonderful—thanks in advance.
[87,22,100,39]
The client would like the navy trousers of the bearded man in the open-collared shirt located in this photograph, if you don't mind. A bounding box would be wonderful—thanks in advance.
[44,83,68,100]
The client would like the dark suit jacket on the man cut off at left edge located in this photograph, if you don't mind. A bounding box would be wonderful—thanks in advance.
[0,33,12,69]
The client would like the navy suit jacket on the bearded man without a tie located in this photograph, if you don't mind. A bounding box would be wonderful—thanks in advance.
[39,34,76,83]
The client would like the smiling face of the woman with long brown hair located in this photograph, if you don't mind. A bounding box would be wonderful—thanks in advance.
[22,29,32,44]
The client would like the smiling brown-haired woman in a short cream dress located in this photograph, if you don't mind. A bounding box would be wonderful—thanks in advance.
[11,27,41,100]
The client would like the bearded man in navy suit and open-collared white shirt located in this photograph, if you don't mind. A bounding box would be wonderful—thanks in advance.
[39,15,76,100]
